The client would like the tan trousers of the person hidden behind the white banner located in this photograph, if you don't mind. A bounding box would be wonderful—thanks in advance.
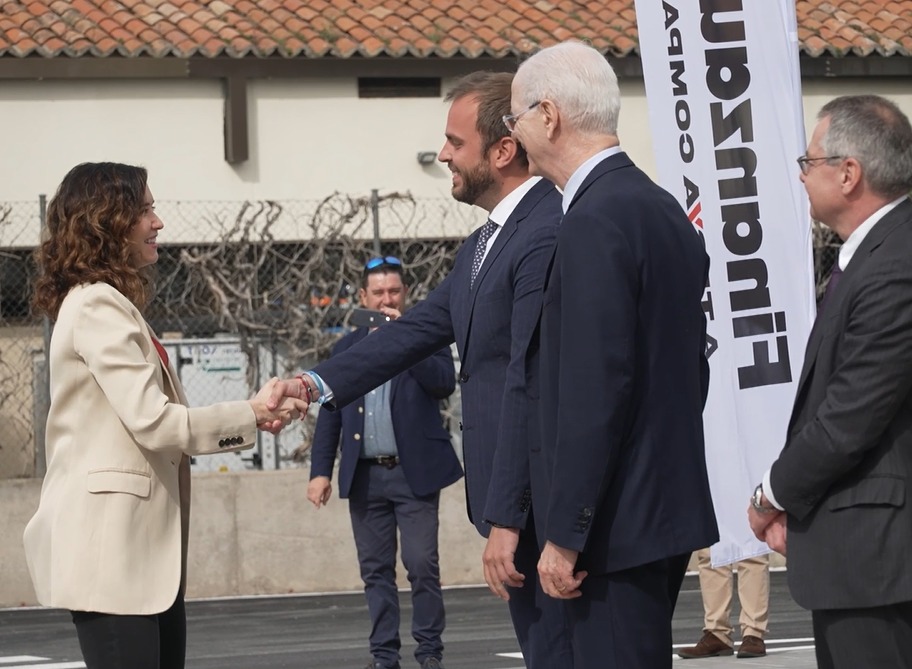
[697,548,769,646]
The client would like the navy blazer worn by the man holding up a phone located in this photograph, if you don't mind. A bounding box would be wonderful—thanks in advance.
[310,326,462,497]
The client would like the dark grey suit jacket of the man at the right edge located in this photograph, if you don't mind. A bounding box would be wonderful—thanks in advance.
[770,199,912,609]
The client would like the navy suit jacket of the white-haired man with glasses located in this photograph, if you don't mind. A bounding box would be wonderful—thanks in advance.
[530,153,719,574]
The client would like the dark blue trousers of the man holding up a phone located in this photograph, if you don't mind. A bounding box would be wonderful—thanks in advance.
[348,461,445,667]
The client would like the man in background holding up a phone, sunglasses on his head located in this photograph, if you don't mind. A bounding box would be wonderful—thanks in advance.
[307,257,462,669]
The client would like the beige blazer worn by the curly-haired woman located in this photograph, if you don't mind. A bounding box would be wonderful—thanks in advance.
[24,283,256,615]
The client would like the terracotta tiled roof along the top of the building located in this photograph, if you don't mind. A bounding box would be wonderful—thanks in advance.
[0,0,912,58]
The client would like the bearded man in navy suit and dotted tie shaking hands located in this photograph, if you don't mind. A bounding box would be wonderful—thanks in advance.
[274,72,572,669]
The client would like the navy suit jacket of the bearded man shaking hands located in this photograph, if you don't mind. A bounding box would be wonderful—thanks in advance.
[315,180,561,536]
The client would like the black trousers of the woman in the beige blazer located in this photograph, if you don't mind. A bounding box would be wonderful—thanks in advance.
[70,594,187,669]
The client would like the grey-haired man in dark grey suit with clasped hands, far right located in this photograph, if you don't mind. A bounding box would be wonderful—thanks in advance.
[748,95,912,669]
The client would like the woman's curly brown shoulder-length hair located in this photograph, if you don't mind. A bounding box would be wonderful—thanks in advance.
[32,163,149,320]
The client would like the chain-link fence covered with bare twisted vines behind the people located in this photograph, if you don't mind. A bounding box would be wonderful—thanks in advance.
[0,191,838,478]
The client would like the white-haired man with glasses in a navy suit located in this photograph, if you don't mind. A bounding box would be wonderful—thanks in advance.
[512,42,719,669]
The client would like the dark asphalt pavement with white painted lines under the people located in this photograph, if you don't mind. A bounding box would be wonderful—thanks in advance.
[0,572,816,669]
